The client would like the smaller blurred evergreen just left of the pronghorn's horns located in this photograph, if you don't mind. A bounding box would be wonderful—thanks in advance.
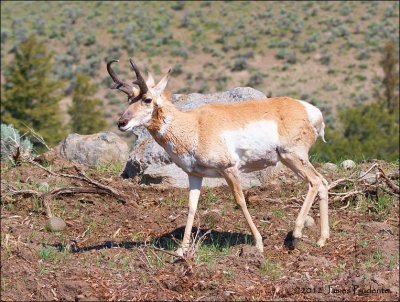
[68,74,106,134]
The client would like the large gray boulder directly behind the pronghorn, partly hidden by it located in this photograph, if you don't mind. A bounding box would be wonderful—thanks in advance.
[122,87,280,188]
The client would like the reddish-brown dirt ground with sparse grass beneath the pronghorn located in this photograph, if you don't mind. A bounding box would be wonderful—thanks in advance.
[1,152,399,301]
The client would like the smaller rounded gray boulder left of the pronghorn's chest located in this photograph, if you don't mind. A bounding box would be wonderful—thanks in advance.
[60,132,129,167]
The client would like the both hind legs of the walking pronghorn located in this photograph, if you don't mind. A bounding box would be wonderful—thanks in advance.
[279,151,329,248]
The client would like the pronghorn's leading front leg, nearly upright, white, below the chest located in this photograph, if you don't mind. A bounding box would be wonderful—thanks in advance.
[176,175,203,256]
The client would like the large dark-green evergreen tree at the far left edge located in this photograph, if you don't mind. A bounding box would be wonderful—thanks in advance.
[1,36,65,144]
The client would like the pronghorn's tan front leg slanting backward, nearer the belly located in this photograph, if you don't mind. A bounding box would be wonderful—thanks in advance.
[222,167,264,253]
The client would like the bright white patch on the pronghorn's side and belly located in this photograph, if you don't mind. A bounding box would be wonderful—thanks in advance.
[222,120,279,172]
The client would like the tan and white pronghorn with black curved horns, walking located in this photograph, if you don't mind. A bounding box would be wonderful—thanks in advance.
[107,59,329,255]
